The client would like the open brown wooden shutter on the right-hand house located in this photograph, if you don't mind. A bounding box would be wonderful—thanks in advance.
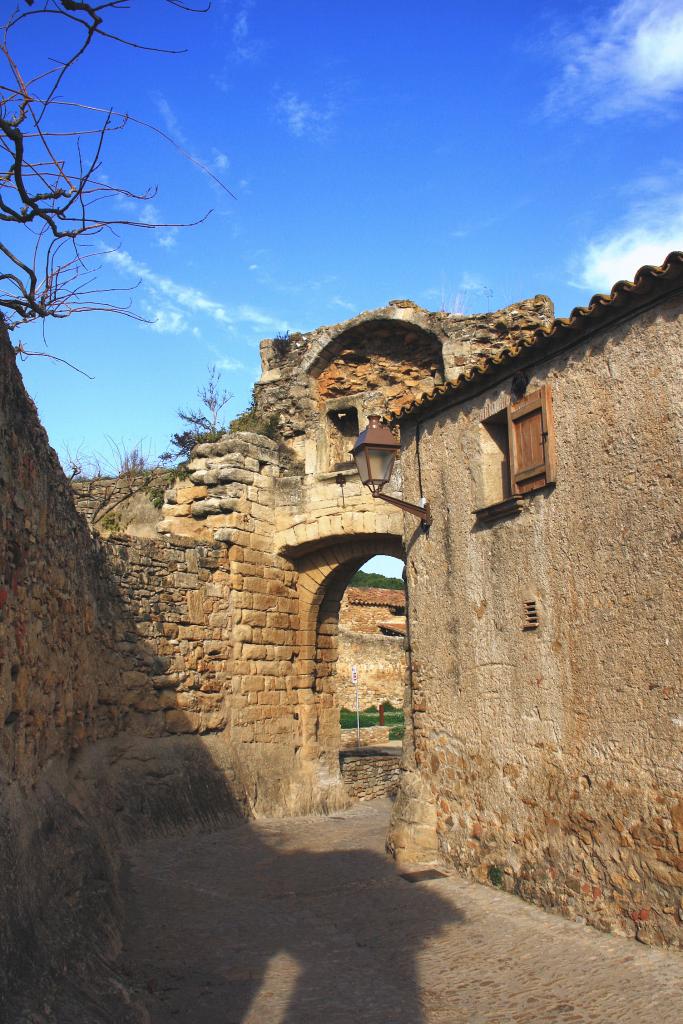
[508,384,555,495]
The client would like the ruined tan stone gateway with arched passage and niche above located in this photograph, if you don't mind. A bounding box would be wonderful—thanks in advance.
[153,300,547,812]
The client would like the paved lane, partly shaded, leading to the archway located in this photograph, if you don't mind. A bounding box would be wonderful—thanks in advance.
[124,801,683,1024]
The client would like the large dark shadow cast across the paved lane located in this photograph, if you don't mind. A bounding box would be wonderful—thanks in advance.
[124,801,459,1024]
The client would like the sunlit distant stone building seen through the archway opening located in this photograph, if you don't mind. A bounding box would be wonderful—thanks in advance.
[335,587,405,710]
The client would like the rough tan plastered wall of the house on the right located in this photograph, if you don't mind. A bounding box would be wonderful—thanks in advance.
[392,293,683,946]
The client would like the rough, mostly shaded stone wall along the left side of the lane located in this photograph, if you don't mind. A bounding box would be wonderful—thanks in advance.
[0,333,247,1024]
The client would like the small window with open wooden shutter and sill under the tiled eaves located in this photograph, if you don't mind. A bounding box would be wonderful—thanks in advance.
[475,384,555,521]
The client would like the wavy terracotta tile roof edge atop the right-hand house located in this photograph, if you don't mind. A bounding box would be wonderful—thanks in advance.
[394,251,683,420]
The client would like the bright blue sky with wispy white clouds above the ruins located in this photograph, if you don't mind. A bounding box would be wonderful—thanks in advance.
[9,0,683,552]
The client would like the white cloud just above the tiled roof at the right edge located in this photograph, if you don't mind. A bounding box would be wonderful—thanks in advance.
[571,191,683,293]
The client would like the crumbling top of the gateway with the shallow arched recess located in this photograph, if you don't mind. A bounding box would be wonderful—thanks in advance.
[255,295,553,475]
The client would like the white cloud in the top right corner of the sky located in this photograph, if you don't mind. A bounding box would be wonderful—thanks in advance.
[547,0,683,121]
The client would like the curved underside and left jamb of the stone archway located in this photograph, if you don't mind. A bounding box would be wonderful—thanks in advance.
[290,534,404,774]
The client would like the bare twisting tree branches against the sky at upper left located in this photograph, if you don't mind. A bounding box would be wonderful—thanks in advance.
[0,0,232,331]
